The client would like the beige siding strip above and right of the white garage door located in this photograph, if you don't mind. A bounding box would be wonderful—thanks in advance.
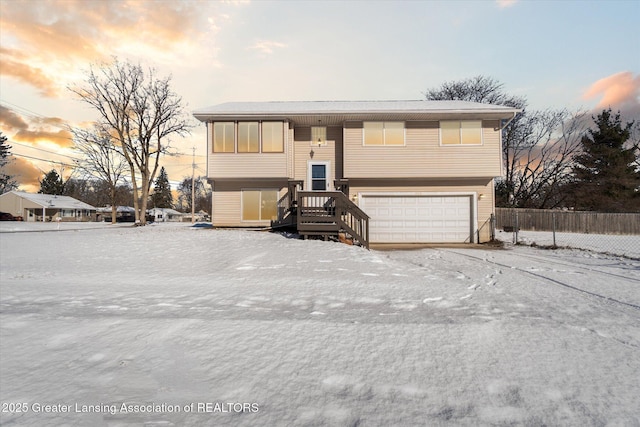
[349,178,494,243]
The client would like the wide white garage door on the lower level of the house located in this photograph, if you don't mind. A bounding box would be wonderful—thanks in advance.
[360,195,473,243]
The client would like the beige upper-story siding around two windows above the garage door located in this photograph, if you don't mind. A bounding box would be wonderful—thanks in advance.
[344,120,501,178]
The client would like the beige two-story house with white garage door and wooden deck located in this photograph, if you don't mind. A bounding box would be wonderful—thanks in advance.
[194,101,519,245]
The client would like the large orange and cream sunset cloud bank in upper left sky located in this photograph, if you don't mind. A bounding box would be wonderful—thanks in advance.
[0,0,226,97]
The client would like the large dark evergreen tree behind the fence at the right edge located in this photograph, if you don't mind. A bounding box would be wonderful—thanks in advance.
[572,109,640,212]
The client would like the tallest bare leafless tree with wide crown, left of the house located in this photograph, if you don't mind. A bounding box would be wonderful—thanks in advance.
[70,59,191,225]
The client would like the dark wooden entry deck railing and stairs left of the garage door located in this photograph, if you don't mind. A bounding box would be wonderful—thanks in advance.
[297,191,369,249]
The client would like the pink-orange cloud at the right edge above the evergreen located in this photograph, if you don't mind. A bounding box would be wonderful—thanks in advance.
[583,71,640,108]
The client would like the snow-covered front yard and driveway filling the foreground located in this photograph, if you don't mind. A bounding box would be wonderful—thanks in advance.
[0,223,640,427]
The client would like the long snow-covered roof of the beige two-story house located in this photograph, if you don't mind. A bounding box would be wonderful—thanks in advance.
[193,100,521,121]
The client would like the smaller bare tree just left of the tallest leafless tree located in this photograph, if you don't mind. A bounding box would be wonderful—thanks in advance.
[70,125,127,224]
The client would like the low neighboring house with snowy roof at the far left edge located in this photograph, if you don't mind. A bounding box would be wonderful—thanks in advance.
[0,191,96,222]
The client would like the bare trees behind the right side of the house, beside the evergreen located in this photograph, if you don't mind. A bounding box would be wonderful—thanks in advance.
[424,76,585,209]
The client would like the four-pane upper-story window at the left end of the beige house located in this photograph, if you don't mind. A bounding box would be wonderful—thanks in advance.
[212,122,284,153]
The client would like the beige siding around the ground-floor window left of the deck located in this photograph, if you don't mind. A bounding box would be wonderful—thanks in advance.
[211,179,287,227]
